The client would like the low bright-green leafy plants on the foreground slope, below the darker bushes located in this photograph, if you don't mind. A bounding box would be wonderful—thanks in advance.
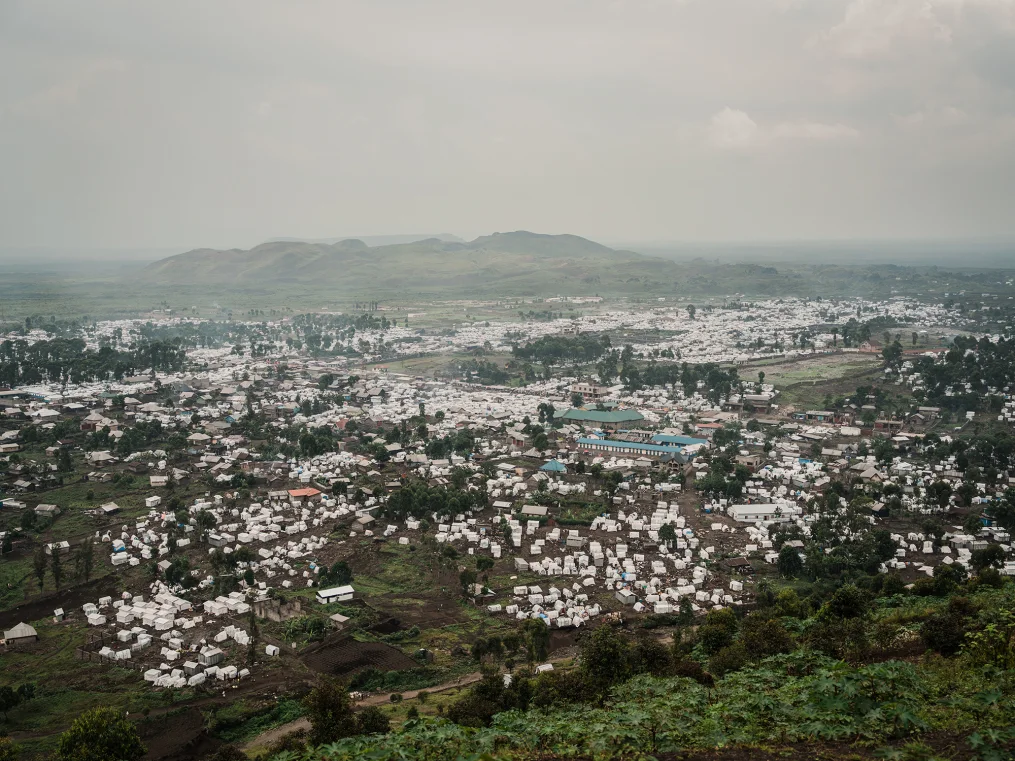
[267,650,1015,761]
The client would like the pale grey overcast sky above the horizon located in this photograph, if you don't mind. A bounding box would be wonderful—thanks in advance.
[0,0,1015,248]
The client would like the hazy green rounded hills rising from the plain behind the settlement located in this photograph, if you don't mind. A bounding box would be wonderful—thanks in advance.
[139,231,678,295]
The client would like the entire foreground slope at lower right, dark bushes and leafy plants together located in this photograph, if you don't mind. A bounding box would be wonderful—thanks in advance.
[263,578,1015,761]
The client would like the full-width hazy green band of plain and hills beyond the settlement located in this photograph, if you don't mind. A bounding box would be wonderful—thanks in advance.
[7,238,1011,324]
